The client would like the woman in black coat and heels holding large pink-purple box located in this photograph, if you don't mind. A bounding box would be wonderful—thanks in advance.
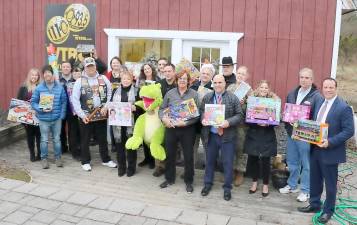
[244,80,279,197]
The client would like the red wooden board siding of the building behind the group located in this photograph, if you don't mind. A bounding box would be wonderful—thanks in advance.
[0,0,336,109]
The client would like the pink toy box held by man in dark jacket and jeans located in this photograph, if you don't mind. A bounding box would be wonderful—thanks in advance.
[283,103,311,123]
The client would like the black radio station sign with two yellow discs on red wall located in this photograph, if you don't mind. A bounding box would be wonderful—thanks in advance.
[45,4,96,74]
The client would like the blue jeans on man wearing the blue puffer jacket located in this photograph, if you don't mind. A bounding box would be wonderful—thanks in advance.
[40,119,62,159]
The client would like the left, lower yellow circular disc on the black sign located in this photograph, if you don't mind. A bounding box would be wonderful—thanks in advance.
[46,16,70,44]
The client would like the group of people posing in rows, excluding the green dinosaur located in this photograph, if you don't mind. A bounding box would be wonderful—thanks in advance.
[18,53,354,223]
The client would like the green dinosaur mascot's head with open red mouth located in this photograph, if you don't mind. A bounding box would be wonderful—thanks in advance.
[135,84,163,111]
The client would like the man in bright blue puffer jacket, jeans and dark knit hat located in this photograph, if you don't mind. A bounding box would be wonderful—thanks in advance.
[31,65,67,169]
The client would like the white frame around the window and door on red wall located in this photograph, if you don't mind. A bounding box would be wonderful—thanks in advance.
[104,28,243,65]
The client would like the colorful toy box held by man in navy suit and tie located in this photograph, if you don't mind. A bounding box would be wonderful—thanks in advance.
[291,120,328,144]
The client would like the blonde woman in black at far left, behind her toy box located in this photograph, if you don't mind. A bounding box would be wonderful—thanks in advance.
[17,68,41,162]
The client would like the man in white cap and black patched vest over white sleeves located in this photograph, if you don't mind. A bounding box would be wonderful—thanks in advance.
[72,57,117,171]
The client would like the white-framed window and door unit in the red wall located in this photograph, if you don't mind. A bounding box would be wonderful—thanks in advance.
[104,28,243,69]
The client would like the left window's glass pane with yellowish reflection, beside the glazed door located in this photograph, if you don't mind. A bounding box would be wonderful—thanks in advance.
[119,39,172,63]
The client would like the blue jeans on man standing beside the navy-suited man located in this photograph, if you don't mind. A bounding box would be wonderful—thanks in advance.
[286,136,310,194]
